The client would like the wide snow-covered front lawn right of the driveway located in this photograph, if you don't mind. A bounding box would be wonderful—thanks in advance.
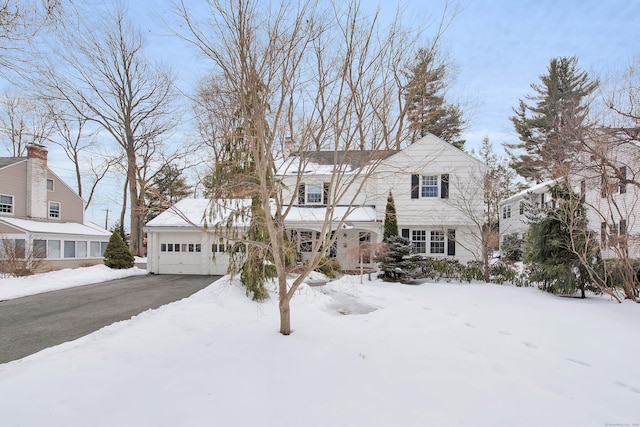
[0,270,640,427]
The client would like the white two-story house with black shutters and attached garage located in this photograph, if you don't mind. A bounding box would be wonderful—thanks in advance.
[145,135,485,274]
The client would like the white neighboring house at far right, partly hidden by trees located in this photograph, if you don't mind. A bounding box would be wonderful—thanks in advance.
[500,130,640,258]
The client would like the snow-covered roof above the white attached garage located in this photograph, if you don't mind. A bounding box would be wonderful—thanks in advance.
[146,199,251,227]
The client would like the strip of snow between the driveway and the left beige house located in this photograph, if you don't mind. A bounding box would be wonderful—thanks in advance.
[0,264,147,301]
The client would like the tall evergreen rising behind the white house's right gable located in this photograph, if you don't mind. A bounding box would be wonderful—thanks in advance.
[404,48,466,148]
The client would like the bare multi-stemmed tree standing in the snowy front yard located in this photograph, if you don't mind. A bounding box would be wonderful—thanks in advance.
[175,0,448,335]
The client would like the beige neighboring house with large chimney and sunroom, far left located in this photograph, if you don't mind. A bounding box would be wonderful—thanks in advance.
[0,144,111,271]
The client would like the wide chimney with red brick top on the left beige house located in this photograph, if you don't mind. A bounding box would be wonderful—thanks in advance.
[27,144,48,219]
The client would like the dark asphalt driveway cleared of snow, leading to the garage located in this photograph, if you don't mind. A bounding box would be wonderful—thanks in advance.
[0,275,220,363]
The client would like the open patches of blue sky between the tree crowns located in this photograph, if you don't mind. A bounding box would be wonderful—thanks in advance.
[82,0,640,224]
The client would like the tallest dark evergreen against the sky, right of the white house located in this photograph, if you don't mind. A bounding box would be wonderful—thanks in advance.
[505,56,599,182]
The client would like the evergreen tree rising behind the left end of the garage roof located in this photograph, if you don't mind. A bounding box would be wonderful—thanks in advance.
[145,164,191,222]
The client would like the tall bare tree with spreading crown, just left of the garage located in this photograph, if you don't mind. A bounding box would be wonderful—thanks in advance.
[38,11,176,255]
